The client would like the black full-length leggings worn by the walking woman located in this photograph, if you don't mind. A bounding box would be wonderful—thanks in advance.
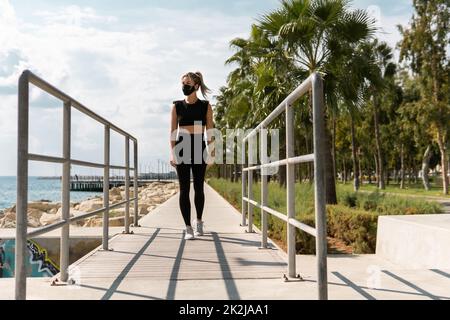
[177,135,207,226]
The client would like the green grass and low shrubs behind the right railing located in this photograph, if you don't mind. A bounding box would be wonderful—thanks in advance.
[208,178,443,254]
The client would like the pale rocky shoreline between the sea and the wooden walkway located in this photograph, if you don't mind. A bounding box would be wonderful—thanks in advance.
[0,182,179,228]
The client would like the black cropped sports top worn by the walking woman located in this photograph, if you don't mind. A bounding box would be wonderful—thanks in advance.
[173,99,209,126]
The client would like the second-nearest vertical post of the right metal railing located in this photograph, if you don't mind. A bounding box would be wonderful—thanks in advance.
[286,103,297,277]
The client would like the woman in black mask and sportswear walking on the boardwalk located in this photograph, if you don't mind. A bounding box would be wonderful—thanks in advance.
[170,72,214,240]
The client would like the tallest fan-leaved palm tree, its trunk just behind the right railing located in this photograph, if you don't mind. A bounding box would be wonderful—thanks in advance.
[259,0,374,204]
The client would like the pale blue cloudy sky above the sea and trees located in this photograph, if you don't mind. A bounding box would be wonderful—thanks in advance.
[0,0,413,176]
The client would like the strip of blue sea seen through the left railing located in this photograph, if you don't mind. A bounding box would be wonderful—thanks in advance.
[0,176,103,210]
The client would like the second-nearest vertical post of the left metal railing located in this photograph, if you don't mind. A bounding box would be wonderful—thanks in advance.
[60,101,72,282]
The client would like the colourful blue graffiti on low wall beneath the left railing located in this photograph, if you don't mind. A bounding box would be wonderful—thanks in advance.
[0,239,59,278]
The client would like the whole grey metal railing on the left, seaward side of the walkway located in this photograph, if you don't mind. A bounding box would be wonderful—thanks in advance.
[15,70,138,300]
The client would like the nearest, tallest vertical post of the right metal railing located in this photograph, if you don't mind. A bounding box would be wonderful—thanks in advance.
[312,73,328,300]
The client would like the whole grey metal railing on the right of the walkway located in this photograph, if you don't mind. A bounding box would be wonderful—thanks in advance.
[241,73,328,300]
